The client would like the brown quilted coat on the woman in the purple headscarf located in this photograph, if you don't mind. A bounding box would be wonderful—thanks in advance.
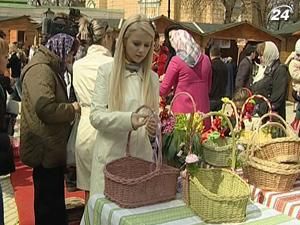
[20,46,75,168]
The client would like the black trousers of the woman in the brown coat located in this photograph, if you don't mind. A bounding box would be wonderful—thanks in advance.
[32,166,67,225]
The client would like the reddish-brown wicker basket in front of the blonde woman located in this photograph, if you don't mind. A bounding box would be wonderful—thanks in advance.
[104,106,179,208]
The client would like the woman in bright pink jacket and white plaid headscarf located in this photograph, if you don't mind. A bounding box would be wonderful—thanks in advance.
[159,29,212,116]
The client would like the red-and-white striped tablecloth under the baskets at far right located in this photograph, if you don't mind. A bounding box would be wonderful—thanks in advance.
[250,180,300,220]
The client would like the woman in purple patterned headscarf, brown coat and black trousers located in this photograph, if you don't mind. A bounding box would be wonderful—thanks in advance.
[20,33,80,225]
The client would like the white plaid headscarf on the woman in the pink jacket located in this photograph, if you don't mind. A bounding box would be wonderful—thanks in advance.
[169,30,201,67]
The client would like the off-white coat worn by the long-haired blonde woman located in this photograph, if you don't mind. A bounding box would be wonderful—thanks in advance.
[90,63,159,195]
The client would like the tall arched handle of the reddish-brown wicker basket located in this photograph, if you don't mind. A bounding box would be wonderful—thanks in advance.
[126,105,162,171]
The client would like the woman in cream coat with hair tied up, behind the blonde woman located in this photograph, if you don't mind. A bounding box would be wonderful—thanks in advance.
[73,19,113,200]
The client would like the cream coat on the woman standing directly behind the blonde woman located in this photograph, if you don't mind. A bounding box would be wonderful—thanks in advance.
[73,45,113,191]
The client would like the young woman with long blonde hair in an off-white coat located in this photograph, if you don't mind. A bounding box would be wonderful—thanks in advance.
[90,15,159,195]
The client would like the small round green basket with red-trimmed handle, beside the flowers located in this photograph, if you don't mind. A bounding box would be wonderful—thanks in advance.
[202,113,235,167]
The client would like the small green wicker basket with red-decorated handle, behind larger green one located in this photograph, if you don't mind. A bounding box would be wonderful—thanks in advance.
[202,110,234,167]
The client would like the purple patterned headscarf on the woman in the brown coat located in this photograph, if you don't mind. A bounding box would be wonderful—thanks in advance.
[46,33,75,62]
